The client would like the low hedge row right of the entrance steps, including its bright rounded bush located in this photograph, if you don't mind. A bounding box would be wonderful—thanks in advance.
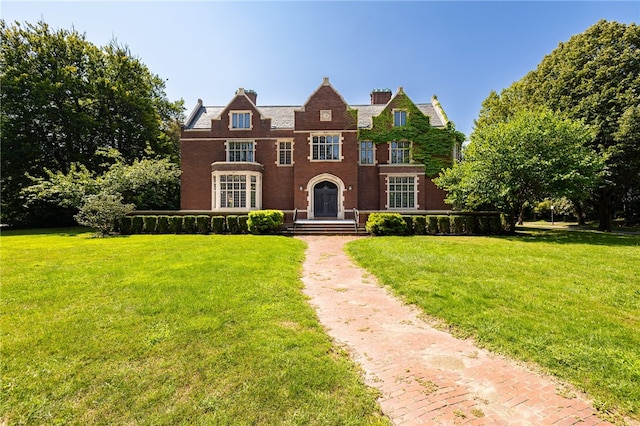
[366,213,505,235]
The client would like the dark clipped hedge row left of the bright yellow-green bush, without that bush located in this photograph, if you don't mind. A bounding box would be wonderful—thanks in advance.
[118,215,249,235]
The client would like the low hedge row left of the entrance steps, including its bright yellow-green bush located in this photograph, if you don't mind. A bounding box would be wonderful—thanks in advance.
[118,210,284,235]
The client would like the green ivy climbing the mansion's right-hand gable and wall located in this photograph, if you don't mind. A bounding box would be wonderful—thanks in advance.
[359,92,465,176]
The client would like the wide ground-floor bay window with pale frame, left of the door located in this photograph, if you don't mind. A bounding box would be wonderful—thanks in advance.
[211,171,262,212]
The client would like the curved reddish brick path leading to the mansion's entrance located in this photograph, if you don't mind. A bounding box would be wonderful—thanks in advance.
[298,236,609,426]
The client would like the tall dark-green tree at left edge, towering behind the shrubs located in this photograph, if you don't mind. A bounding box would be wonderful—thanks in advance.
[0,21,183,224]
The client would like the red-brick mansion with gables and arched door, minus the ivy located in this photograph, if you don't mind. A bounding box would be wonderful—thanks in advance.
[181,79,448,219]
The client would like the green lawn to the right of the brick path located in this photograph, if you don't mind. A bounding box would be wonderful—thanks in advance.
[347,230,640,419]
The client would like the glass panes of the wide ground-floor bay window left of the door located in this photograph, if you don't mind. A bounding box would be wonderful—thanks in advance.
[213,174,258,209]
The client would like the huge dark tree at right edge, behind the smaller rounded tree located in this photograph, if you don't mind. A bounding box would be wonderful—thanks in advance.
[476,20,640,230]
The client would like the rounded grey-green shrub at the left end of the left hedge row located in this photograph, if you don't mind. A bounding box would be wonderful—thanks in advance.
[74,192,133,236]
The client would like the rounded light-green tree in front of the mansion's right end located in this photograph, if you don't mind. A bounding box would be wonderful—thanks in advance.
[434,109,603,231]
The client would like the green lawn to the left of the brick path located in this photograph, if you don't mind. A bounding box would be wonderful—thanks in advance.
[0,229,386,425]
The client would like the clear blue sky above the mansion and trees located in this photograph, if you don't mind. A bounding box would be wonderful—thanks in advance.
[0,0,640,136]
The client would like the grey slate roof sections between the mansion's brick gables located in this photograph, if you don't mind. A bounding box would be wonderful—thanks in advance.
[185,104,445,130]
